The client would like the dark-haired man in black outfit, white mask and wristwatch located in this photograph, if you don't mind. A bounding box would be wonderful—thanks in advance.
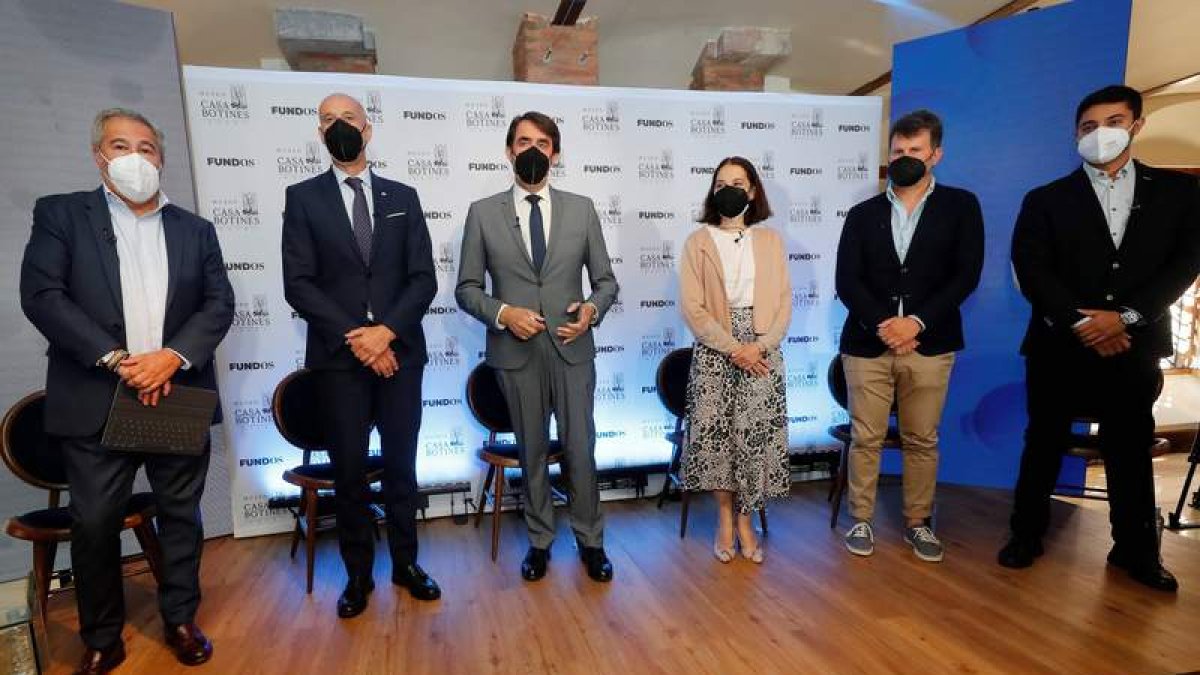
[998,86,1200,591]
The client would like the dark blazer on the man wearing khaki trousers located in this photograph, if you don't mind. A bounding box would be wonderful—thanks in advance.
[836,183,984,358]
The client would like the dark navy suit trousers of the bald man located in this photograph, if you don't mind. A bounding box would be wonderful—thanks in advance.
[319,368,425,577]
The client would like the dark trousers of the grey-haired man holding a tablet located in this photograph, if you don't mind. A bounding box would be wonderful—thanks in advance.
[61,436,209,649]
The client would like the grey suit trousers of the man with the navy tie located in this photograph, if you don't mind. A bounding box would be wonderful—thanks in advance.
[497,331,604,549]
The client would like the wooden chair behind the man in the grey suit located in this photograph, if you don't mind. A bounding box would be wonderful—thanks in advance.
[467,363,563,562]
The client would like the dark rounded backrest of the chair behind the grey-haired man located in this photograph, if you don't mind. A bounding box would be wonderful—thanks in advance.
[0,392,67,492]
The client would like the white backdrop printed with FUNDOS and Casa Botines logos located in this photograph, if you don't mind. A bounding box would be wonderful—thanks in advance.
[184,66,882,536]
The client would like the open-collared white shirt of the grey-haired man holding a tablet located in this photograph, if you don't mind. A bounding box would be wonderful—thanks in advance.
[104,185,191,370]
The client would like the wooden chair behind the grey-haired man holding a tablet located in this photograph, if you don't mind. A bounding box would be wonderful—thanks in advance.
[0,392,162,625]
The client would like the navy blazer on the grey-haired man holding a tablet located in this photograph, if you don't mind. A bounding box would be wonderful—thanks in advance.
[20,187,234,436]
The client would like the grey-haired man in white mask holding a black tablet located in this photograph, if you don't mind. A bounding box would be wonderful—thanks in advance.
[20,108,234,673]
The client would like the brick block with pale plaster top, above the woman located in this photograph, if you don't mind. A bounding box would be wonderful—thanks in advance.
[689,28,792,91]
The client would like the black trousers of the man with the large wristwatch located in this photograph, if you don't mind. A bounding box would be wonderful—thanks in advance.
[1010,352,1159,557]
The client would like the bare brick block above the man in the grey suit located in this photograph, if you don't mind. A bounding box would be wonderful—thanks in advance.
[512,12,600,84]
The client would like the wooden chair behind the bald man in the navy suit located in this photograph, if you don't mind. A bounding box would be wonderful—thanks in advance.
[271,369,383,593]
